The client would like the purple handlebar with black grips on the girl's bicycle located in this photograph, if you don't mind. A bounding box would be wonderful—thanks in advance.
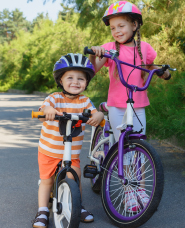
[84,47,176,91]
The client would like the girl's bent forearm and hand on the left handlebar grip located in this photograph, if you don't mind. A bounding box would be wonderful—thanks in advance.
[89,46,107,73]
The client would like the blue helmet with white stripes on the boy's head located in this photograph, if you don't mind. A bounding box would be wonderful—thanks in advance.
[53,53,95,95]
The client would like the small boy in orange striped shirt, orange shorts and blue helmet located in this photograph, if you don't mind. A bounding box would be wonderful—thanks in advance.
[33,53,104,228]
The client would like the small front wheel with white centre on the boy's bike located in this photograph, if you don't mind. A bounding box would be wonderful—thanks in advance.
[53,179,81,228]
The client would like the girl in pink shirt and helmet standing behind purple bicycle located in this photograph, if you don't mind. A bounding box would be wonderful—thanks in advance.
[89,1,170,212]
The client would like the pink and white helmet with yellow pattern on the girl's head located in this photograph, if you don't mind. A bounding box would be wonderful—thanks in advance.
[102,1,143,26]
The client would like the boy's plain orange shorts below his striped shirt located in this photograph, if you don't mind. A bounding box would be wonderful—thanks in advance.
[38,152,80,179]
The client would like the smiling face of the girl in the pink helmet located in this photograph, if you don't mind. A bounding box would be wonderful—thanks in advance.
[109,16,137,45]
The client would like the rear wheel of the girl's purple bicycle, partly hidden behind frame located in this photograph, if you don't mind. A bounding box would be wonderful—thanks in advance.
[90,126,109,193]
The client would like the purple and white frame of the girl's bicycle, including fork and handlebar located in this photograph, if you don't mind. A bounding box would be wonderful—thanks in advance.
[89,53,158,184]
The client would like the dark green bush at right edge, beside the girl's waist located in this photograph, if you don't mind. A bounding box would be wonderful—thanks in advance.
[146,73,185,142]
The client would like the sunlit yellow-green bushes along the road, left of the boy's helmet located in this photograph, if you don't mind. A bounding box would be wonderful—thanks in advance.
[0,14,107,97]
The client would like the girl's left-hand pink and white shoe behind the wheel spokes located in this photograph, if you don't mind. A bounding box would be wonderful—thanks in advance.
[123,191,141,213]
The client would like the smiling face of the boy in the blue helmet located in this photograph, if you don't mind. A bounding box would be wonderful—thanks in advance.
[60,70,87,94]
